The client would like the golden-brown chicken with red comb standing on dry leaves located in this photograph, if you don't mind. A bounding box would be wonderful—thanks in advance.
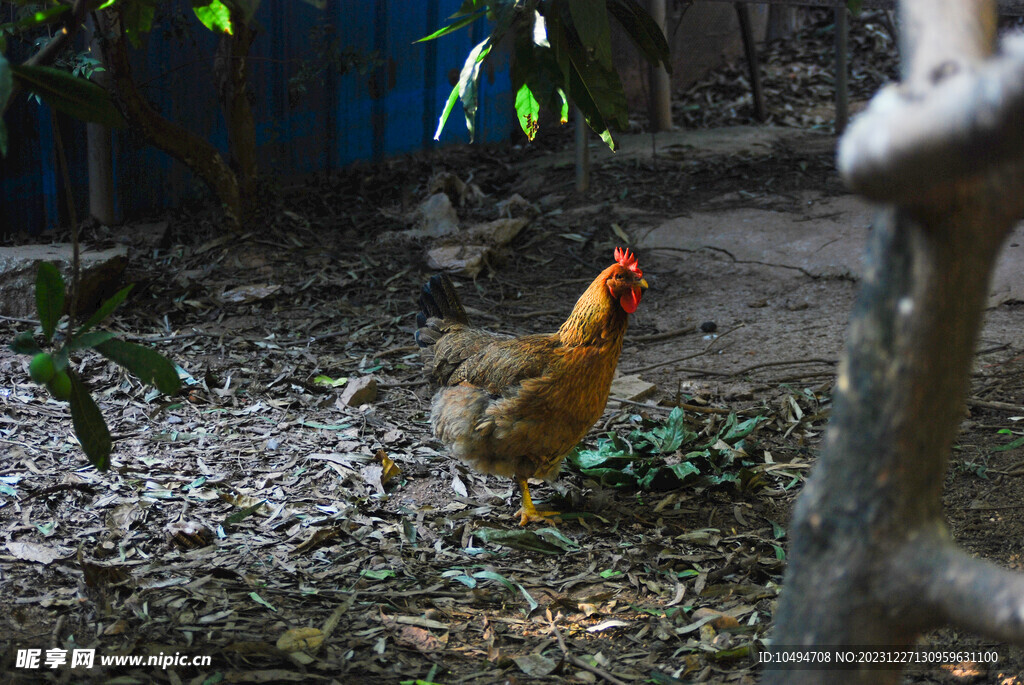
[416,248,647,525]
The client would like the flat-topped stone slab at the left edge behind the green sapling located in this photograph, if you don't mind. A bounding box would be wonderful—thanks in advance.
[0,244,128,317]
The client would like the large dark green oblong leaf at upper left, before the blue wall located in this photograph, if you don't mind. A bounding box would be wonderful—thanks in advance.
[10,65,125,128]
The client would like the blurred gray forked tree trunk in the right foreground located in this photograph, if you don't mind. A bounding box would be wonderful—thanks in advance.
[764,0,1024,684]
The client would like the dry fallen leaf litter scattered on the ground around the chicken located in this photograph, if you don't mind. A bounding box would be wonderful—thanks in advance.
[6,7,1024,683]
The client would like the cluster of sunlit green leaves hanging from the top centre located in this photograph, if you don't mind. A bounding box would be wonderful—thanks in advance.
[420,0,671,149]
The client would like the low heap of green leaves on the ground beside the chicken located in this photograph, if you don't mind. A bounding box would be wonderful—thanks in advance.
[566,406,764,489]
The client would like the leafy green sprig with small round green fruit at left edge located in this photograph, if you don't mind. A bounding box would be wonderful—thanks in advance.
[10,262,181,470]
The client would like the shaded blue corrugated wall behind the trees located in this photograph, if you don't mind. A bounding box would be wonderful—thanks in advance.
[0,0,515,233]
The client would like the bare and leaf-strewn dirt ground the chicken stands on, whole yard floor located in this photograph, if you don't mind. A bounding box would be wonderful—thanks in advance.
[6,9,1024,684]
